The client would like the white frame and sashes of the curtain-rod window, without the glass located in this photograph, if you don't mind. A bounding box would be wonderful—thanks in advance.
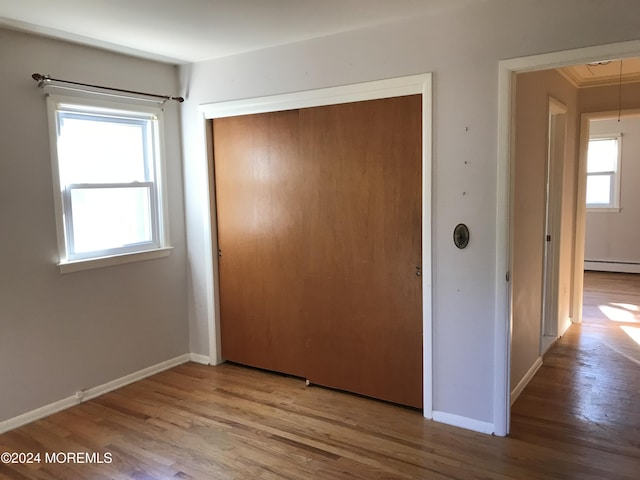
[47,93,172,273]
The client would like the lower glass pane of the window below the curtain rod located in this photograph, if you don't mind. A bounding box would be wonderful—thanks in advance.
[71,186,153,254]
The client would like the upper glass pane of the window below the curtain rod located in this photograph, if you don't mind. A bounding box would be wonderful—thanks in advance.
[58,113,149,185]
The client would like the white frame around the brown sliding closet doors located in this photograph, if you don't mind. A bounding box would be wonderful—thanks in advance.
[198,73,433,419]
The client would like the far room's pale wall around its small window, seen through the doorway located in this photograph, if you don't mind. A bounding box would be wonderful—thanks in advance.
[584,116,640,272]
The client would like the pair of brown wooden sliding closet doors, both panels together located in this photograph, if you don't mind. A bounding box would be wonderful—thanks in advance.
[213,95,422,407]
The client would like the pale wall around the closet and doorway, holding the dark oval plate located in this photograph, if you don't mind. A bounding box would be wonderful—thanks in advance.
[180,0,640,430]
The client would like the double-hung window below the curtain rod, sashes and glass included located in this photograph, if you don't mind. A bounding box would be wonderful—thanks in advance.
[48,95,166,271]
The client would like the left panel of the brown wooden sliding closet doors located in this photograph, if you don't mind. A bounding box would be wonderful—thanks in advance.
[213,111,307,377]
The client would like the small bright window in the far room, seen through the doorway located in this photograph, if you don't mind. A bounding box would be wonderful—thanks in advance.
[587,134,622,211]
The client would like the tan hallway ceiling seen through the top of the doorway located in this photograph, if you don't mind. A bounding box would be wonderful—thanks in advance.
[558,58,640,87]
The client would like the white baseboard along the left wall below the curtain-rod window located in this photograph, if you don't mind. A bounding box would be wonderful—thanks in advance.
[0,353,191,434]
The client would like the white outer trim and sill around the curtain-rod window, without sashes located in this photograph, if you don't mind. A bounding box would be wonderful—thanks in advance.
[46,93,173,273]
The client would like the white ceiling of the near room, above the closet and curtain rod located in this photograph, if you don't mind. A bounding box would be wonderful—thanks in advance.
[0,0,483,63]
